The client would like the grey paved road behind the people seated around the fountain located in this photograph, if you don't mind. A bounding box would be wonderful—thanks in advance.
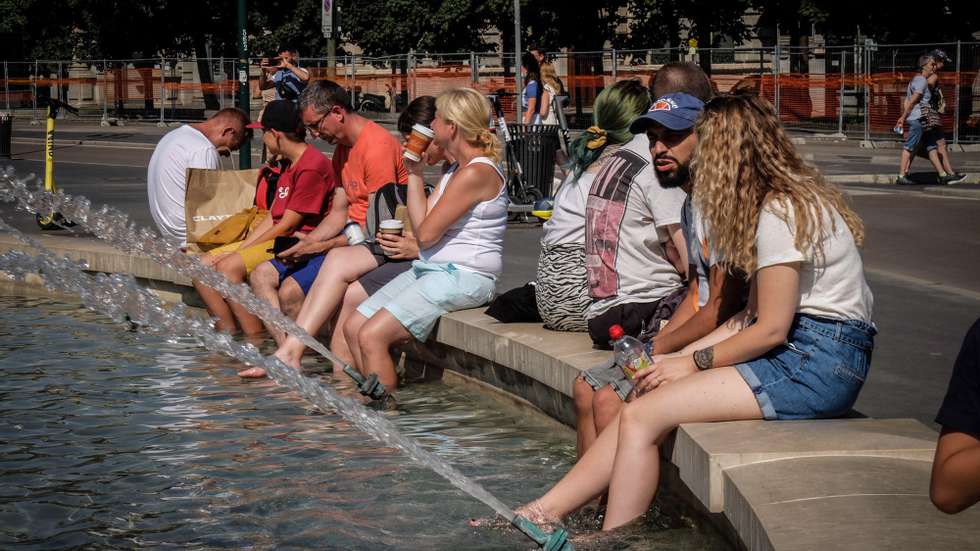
[0,134,980,423]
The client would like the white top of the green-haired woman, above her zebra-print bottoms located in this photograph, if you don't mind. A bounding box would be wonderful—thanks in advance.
[541,145,619,245]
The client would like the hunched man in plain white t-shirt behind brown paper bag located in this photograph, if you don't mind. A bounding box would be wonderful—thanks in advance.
[146,108,249,243]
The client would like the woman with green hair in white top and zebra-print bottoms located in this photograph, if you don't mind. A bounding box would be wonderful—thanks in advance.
[535,79,650,331]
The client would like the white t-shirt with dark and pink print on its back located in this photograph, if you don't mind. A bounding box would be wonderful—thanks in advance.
[585,134,686,319]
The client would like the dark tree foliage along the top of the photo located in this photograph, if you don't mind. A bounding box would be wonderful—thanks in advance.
[0,0,980,59]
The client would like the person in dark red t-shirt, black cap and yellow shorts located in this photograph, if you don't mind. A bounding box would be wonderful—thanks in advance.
[194,100,347,335]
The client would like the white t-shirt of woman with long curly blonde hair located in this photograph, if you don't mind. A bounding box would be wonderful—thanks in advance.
[755,202,874,323]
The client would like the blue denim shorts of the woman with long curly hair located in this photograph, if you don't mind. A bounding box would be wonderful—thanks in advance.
[735,314,877,419]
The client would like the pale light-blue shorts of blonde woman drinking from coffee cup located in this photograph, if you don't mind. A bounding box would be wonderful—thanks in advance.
[357,260,496,341]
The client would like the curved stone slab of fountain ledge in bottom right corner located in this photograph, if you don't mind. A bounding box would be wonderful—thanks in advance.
[725,456,980,551]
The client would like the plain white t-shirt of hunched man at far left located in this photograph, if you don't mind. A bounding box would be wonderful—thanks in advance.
[146,125,220,242]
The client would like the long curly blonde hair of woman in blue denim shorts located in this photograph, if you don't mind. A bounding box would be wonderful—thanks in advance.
[691,94,864,274]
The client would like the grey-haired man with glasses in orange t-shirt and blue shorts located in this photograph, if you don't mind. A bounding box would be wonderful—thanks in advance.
[249,80,408,343]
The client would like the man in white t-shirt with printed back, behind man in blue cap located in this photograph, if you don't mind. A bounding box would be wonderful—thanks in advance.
[585,94,688,349]
